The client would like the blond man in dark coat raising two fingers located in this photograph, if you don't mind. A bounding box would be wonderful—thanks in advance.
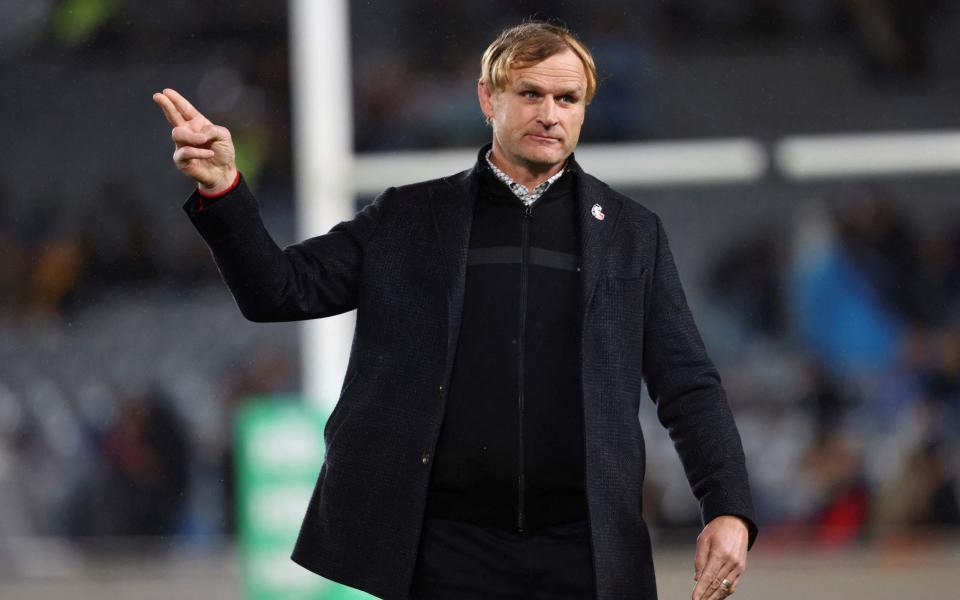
[154,22,756,600]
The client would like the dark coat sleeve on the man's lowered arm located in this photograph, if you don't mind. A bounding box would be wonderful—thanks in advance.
[643,212,757,546]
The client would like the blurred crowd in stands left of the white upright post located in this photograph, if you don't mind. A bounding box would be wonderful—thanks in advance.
[0,0,299,548]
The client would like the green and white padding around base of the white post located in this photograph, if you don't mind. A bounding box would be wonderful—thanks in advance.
[234,396,373,600]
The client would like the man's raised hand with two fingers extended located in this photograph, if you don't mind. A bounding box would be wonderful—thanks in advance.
[153,88,237,194]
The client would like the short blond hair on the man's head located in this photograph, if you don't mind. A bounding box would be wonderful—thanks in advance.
[480,21,597,104]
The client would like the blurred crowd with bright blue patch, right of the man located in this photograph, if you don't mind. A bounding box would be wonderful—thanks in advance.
[692,186,960,547]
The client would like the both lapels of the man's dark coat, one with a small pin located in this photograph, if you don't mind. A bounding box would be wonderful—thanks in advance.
[431,144,622,318]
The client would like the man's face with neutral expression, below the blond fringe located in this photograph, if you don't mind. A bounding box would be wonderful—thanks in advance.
[477,50,587,173]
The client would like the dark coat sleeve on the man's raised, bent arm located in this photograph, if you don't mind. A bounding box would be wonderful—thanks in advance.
[183,178,390,322]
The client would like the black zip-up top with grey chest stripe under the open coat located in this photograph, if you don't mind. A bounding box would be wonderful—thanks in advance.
[427,156,587,532]
